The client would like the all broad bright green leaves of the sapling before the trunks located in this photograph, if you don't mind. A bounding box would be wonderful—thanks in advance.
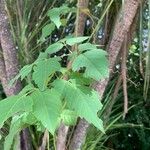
[0,6,108,150]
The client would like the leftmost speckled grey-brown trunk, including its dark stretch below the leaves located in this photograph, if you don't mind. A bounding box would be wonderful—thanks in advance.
[0,0,31,150]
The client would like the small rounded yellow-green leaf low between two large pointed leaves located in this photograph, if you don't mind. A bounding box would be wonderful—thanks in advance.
[61,109,77,126]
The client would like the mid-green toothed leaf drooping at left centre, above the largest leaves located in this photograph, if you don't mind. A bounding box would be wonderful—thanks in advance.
[32,57,61,91]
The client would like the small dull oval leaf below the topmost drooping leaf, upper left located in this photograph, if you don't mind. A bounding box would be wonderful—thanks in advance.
[40,23,55,41]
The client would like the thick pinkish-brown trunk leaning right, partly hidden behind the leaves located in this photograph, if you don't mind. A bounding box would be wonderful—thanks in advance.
[70,0,140,150]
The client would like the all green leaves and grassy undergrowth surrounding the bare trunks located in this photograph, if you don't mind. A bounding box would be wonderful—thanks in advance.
[0,0,150,150]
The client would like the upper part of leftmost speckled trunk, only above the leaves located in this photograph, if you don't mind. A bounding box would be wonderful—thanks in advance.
[0,0,21,96]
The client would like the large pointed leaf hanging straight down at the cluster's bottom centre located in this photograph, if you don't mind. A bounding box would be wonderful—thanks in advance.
[31,89,62,134]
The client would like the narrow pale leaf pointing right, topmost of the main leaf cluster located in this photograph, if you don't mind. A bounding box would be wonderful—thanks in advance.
[66,36,89,46]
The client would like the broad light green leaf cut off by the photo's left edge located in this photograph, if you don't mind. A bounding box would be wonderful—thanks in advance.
[0,96,33,127]
